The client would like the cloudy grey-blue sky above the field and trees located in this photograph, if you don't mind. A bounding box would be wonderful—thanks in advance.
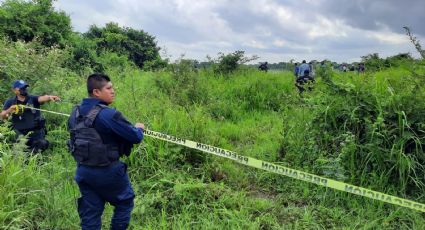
[55,0,425,62]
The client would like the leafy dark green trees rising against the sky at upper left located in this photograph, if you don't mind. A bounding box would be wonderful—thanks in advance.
[0,0,166,71]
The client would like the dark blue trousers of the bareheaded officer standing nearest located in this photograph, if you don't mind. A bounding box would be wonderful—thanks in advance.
[75,162,134,230]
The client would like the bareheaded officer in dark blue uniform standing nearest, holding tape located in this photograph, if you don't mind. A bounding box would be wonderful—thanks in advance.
[68,73,144,230]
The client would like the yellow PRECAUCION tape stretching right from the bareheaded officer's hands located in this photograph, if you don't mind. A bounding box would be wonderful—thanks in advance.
[144,130,425,212]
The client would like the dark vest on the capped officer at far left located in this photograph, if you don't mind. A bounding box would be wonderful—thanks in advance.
[12,97,41,132]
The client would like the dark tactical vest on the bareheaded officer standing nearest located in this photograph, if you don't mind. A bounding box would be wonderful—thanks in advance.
[68,104,120,166]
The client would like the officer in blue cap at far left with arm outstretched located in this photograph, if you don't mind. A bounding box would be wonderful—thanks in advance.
[0,80,60,152]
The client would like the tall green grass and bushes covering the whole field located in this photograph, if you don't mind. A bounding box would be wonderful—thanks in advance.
[0,1,425,229]
